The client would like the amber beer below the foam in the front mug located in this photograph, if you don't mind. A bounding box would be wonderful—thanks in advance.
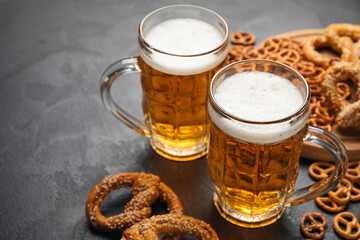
[208,120,307,227]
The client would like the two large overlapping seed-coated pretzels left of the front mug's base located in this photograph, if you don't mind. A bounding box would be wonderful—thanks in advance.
[85,173,219,240]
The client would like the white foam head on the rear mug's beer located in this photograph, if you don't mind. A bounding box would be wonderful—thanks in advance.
[139,18,227,75]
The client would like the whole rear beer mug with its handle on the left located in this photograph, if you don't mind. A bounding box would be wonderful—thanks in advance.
[100,5,228,161]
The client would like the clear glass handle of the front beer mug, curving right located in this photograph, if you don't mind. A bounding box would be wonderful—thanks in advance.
[285,126,348,206]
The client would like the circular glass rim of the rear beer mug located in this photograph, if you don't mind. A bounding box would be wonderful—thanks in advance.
[138,4,229,57]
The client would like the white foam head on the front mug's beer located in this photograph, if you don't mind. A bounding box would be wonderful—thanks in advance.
[209,72,307,144]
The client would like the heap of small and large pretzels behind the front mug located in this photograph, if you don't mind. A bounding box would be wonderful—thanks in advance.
[228,24,360,131]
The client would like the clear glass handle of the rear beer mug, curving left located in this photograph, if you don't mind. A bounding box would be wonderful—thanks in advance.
[100,57,150,137]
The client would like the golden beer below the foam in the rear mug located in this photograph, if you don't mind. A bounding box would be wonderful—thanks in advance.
[138,57,225,158]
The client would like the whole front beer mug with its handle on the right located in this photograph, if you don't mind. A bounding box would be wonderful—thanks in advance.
[207,60,348,228]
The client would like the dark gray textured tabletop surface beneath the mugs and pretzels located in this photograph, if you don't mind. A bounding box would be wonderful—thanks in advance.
[0,0,360,240]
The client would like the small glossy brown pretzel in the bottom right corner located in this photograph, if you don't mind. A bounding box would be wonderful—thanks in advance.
[333,212,360,239]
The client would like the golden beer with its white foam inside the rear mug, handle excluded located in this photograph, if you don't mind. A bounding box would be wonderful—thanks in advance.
[138,13,228,160]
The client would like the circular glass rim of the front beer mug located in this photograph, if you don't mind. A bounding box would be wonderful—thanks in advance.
[209,59,310,125]
